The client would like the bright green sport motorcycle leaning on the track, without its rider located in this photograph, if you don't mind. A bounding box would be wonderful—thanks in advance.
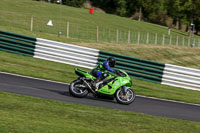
[69,68,135,105]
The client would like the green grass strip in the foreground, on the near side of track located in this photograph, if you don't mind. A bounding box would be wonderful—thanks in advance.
[0,92,200,133]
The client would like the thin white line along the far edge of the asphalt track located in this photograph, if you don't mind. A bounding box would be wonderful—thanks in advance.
[0,72,200,107]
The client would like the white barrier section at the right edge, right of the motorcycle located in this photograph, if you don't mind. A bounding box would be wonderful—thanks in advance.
[161,64,200,91]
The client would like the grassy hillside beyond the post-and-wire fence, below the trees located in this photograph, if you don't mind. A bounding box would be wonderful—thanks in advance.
[0,0,199,46]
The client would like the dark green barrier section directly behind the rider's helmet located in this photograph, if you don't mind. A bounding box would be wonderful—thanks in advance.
[99,51,165,83]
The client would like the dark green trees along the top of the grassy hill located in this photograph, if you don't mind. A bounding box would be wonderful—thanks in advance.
[38,0,200,34]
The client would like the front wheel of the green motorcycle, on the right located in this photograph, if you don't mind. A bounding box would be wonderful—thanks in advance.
[116,88,135,105]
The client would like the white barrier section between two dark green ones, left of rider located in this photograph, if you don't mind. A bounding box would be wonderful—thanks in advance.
[34,38,99,69]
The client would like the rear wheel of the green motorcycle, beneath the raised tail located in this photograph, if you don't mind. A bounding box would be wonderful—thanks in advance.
[69,80,88,98]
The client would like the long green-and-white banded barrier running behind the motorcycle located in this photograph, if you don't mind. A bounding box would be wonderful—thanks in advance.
[0,31,200,91]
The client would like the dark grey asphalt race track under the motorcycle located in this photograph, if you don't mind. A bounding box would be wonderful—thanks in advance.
[0,73,200,122]
